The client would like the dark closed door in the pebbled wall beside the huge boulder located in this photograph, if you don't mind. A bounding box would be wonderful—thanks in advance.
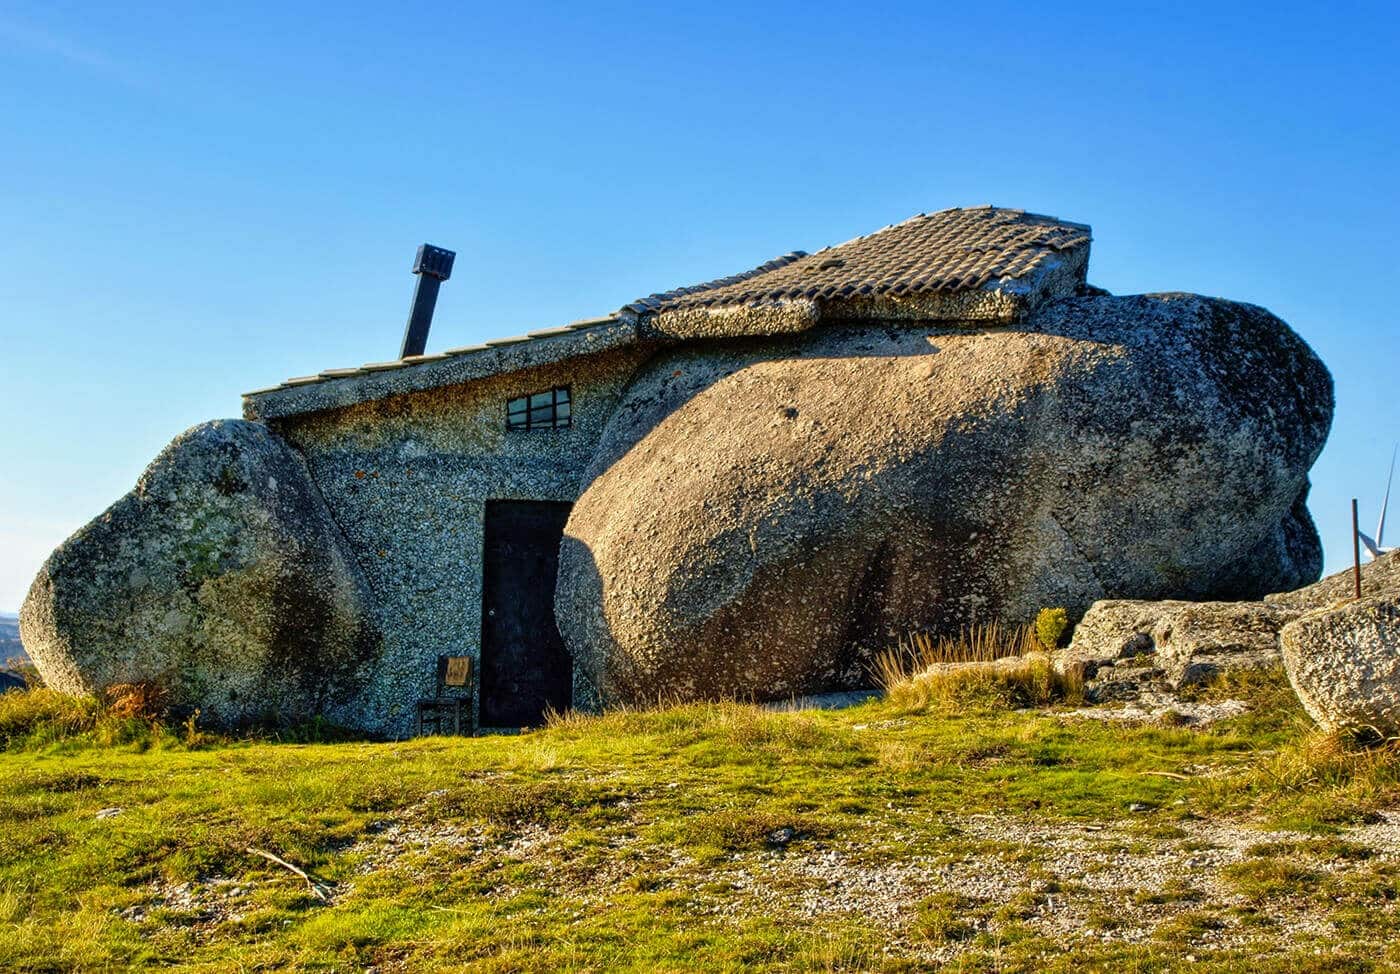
[480,501,573,728]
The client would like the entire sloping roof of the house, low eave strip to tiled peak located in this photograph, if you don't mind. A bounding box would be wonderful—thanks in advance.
[244,206,1091,420]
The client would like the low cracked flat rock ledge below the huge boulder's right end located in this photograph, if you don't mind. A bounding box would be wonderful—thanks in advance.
[1056,599,1302,703]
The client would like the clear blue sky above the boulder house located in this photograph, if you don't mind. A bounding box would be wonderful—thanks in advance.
[0,0,1400,610]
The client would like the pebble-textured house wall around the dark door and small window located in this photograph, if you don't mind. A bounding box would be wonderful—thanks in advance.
[272,346,650,736]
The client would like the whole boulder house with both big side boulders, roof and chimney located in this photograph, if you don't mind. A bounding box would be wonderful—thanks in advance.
[21,207,1333,736]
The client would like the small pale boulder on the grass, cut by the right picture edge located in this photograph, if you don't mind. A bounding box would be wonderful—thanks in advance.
[1280,595,1400,737]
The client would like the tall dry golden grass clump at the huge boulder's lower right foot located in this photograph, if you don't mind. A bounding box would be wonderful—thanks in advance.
[875,623,1084,711]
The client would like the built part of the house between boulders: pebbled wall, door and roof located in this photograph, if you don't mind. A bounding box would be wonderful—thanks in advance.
[244,207,1089,728]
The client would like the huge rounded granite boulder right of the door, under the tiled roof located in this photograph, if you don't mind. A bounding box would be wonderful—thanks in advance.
[556,294,1333,703]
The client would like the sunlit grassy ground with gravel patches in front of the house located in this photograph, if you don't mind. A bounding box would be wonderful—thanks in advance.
[0,675,1400,974]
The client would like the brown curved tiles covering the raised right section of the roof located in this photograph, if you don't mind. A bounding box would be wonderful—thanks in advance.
[622,206,1089,315]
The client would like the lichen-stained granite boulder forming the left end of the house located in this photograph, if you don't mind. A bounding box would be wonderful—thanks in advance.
[20,420,379,725]
